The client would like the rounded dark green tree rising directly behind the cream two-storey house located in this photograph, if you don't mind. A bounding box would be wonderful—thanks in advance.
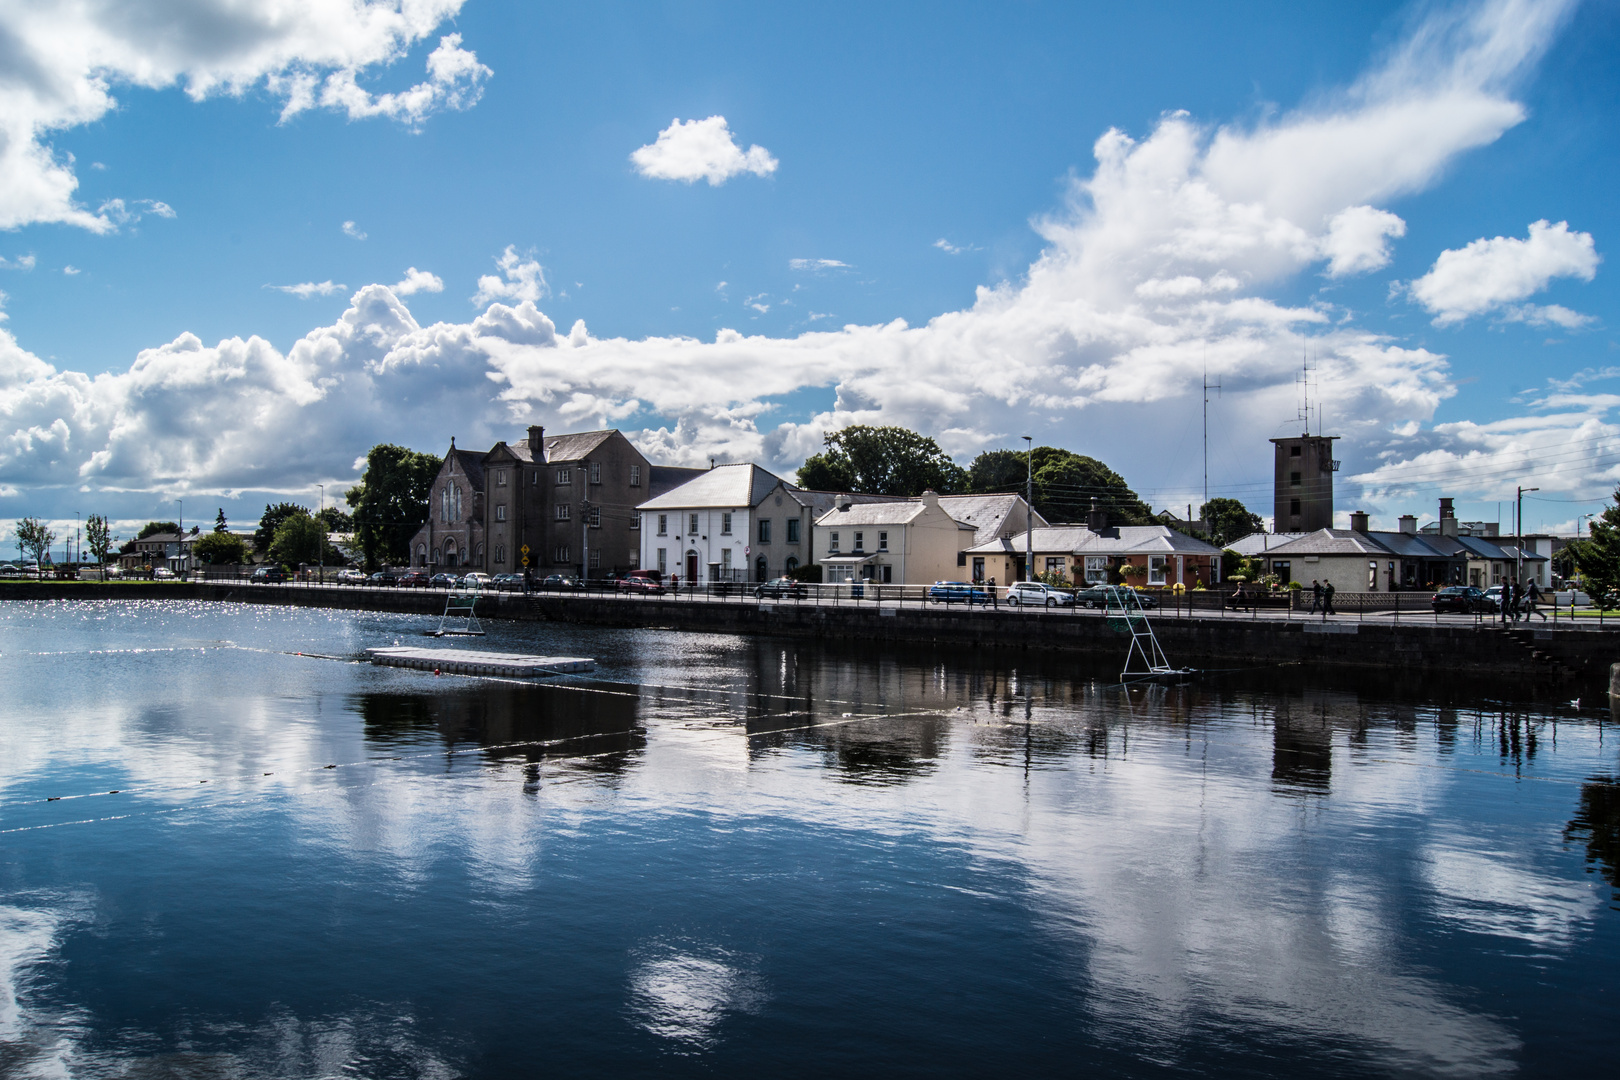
[799,424,967,497]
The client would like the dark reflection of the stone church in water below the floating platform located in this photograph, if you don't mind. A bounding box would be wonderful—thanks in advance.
[353,680,646,772]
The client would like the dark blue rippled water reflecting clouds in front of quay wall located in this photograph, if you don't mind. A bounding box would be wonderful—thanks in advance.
[0,602,1620,1077]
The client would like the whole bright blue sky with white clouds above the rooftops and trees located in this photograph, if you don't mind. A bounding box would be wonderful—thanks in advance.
[0,0,1620,550]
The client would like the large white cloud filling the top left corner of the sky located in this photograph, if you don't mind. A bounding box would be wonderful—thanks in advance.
[0,0,491,233]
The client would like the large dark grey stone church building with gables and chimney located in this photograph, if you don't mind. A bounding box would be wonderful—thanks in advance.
[410,426,705,578]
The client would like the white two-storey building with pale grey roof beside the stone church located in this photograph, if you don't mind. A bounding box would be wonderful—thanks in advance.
[637,465,815,585]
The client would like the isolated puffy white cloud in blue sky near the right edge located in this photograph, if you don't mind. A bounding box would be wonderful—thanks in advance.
[1411,220,1599,325]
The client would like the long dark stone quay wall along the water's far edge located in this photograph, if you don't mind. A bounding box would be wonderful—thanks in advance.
[0,581,1620,696]
